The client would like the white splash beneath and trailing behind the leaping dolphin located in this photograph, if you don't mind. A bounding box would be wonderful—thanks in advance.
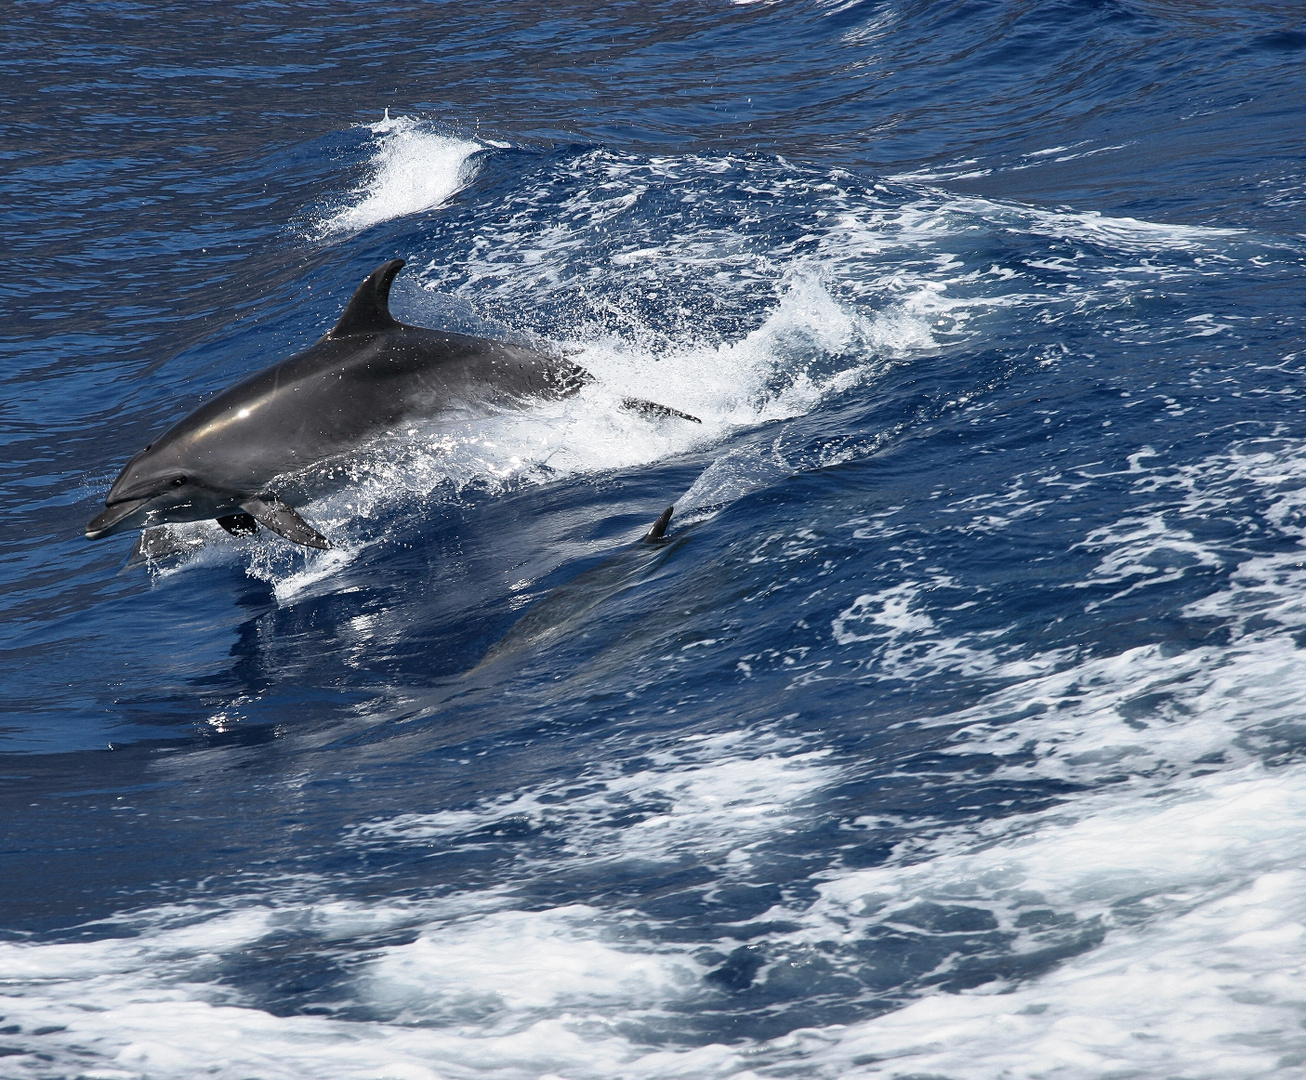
[145,273,934,603]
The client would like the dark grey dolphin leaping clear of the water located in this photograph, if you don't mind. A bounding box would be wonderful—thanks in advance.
[86,259,701,552]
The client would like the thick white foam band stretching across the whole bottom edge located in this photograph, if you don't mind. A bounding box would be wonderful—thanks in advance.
[12,744,1306,1080]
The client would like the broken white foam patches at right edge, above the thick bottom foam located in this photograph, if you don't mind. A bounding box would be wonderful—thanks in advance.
[794,440,1306,790]
